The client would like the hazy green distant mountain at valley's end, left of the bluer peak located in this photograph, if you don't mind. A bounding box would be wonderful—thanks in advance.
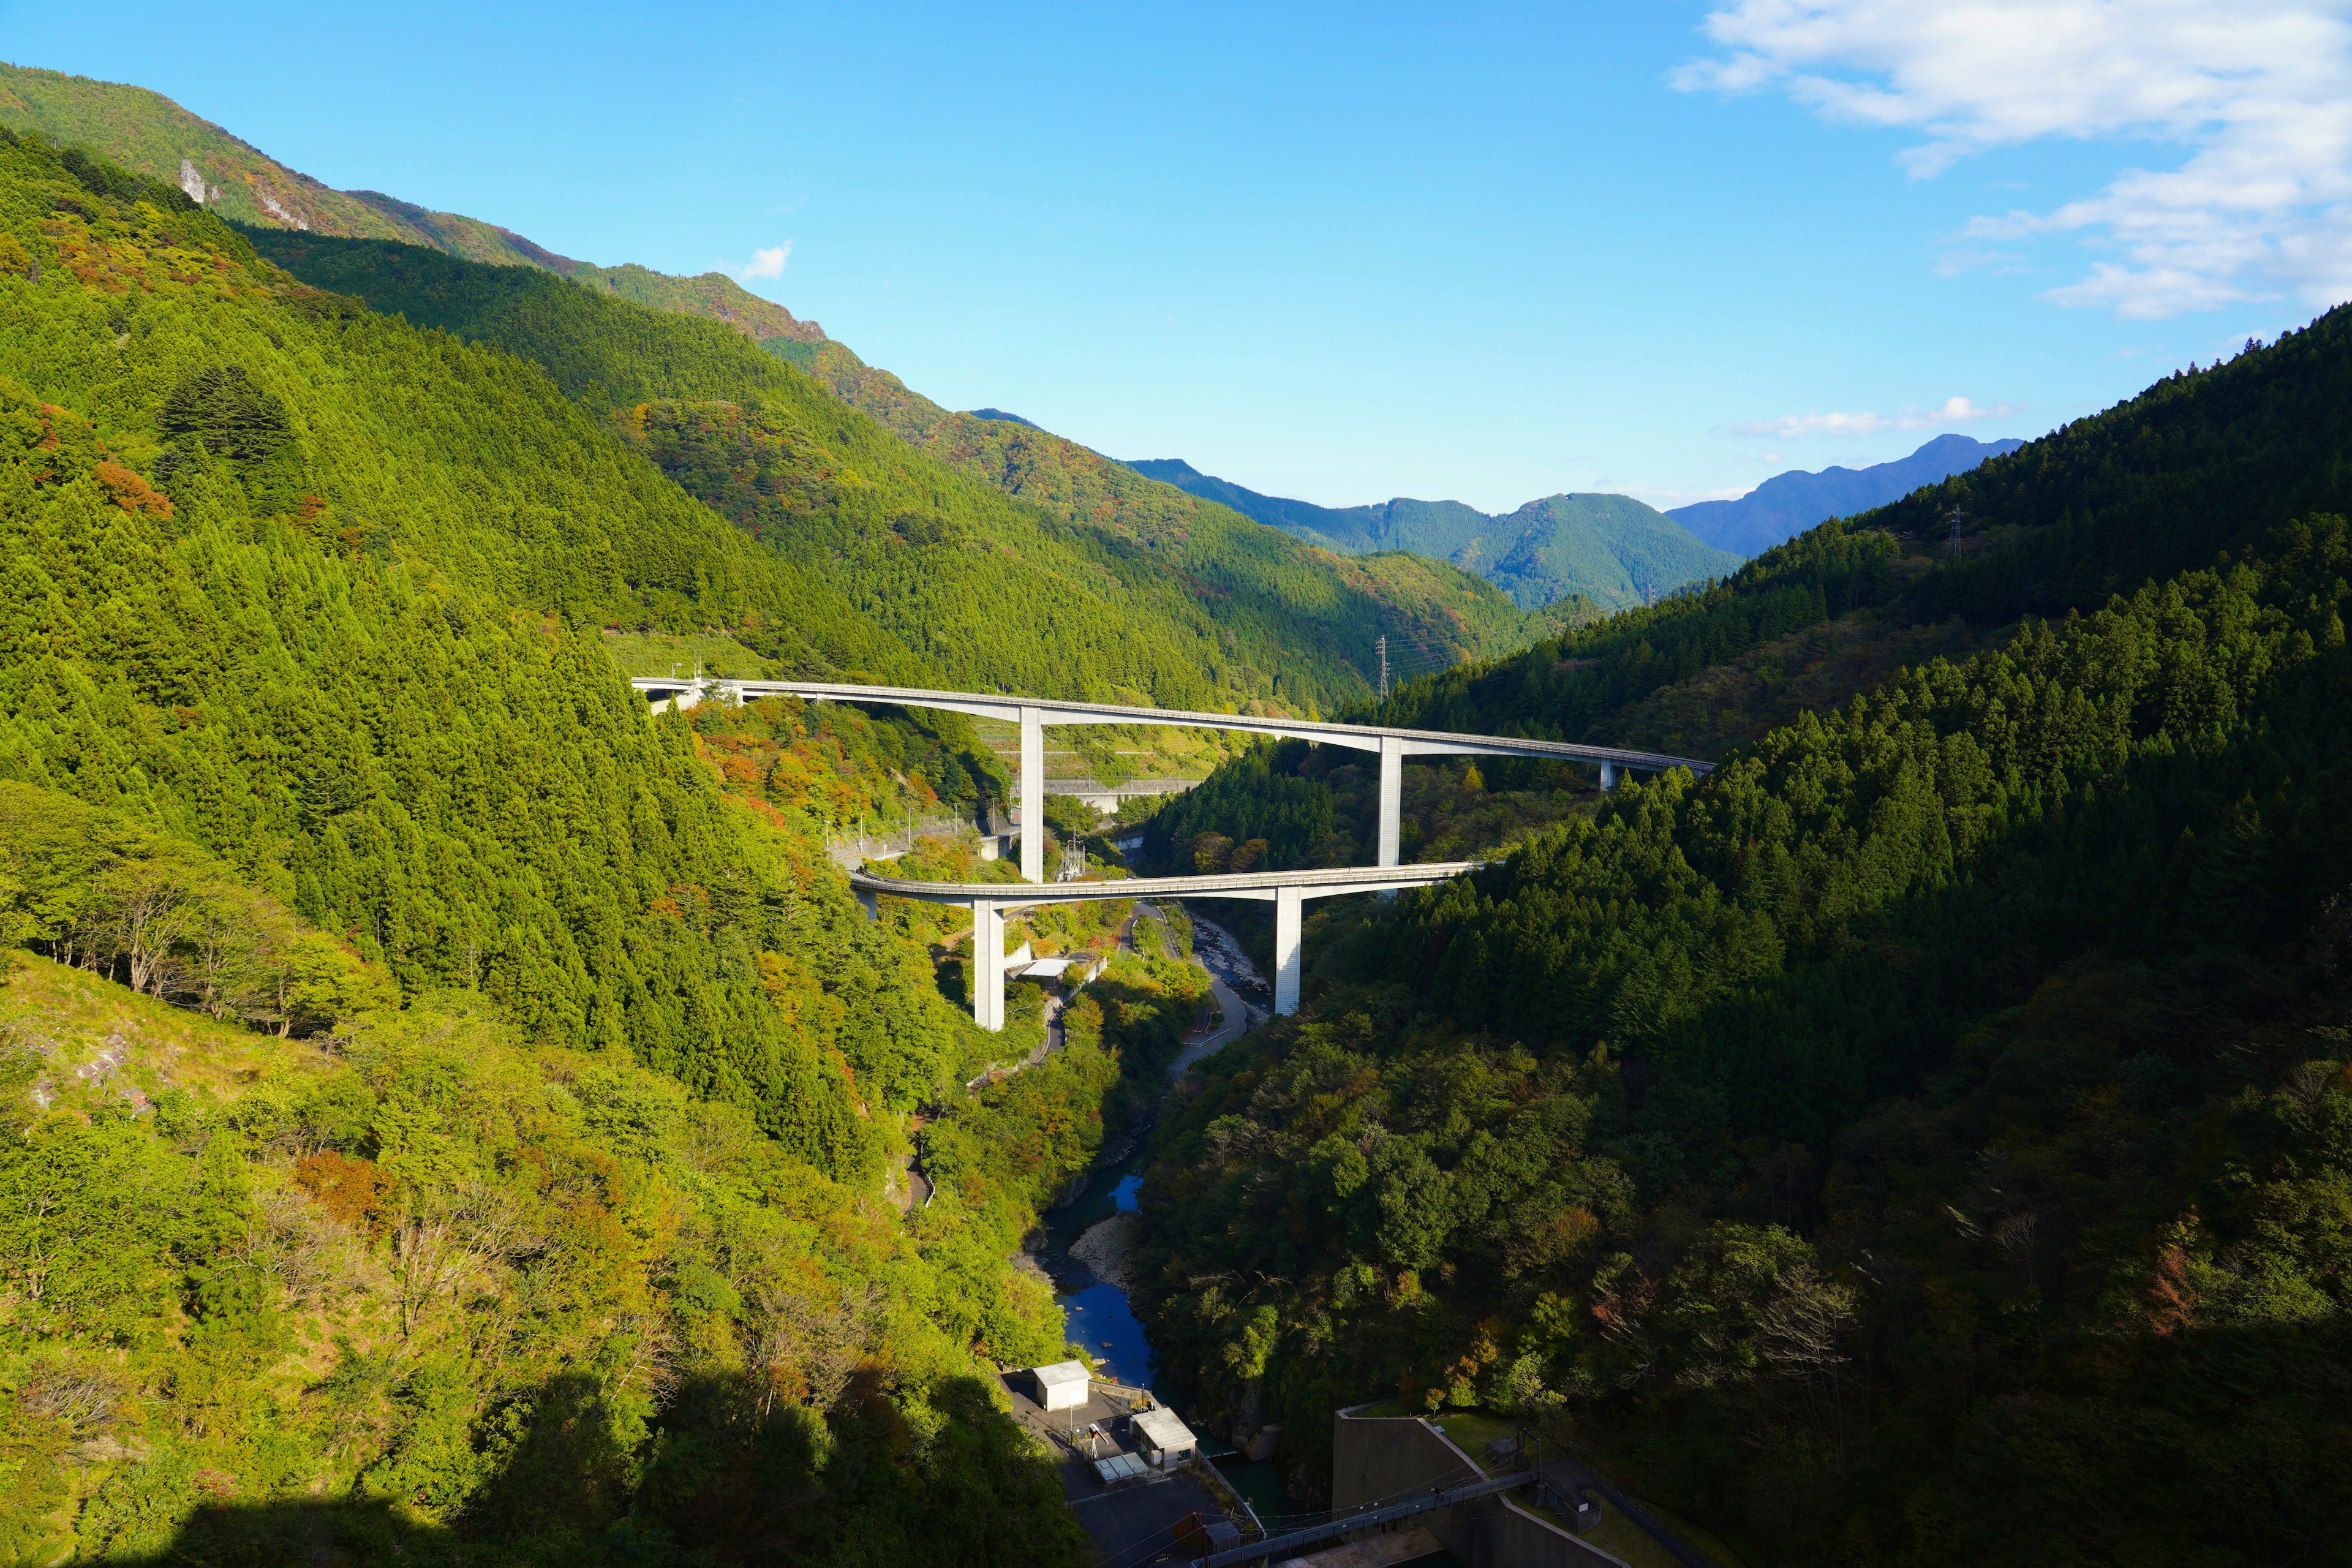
[1110,458,1743,609]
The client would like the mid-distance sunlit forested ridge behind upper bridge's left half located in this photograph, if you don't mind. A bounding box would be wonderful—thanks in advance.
[252,230,1521,707]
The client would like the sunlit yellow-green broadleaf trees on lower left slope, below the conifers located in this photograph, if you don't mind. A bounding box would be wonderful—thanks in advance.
[0,957,1077,1563]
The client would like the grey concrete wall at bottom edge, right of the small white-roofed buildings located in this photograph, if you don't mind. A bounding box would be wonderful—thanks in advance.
[1331,1406,1625,1568]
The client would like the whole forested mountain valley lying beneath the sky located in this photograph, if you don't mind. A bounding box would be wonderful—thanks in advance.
[0,40,2352,1568]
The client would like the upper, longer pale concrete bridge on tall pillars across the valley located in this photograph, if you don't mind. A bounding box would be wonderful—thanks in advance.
[630,675,1714,895]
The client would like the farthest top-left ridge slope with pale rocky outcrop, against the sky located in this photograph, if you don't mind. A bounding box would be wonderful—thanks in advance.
[0,64,569,270]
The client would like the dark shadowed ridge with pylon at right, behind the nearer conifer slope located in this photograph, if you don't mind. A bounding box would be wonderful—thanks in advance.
[1366,311,2352,741]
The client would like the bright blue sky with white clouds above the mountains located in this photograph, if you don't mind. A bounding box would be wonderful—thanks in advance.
[0,0,2352,510]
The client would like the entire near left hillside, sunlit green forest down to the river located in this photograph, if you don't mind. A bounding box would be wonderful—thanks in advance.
[0,134,1164,1563]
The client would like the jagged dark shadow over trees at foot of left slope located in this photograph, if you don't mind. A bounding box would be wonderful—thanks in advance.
[82,1361,1091,1568]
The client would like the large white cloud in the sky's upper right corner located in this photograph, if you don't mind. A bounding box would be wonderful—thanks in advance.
[1672,0,2352,320]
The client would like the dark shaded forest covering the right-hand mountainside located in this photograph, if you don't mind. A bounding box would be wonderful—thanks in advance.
[1115,312,2352,1566]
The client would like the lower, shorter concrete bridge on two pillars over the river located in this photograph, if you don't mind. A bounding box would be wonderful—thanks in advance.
[849,861,1484,1030]
